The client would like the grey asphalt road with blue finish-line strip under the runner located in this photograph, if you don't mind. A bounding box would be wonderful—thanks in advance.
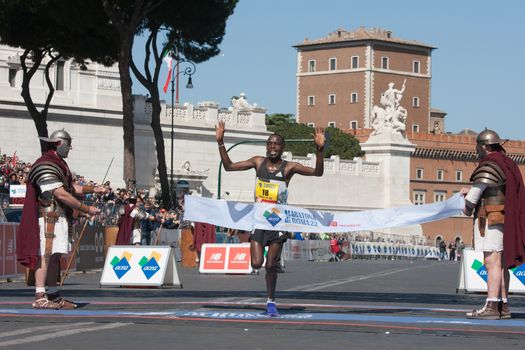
[0,260,525,350]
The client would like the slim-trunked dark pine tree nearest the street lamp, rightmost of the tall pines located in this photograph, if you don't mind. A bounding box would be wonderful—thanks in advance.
[130,0,238,206]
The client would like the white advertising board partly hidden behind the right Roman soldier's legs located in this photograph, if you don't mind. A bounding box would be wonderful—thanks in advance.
[456,249,525,294]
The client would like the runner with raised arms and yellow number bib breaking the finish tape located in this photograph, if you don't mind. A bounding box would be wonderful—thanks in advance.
[215,121,325,317]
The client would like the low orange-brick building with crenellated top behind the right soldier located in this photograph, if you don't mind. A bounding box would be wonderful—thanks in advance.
[347,129,525,245]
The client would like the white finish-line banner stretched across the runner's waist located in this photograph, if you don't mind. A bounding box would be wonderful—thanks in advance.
[184,194,465,233]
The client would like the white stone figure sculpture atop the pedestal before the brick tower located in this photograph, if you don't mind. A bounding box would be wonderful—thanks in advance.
[370,79,408,136]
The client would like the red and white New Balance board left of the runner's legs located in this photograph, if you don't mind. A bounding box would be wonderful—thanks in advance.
[199,243,252,274]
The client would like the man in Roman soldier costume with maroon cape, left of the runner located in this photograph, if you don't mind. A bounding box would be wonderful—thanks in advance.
[16,130,105,309]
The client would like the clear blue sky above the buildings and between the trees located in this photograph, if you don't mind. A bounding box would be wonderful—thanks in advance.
[133,0,525,140]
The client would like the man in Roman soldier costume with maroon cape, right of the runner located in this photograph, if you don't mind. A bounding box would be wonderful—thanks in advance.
[461,129,525,320]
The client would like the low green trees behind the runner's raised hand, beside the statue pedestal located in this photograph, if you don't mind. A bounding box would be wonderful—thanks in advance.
[266,114,364,159]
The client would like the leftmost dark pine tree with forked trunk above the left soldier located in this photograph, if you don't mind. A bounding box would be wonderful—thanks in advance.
[0,0,115,151]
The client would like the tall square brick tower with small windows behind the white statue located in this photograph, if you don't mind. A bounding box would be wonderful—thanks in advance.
[295,28,434,132]
